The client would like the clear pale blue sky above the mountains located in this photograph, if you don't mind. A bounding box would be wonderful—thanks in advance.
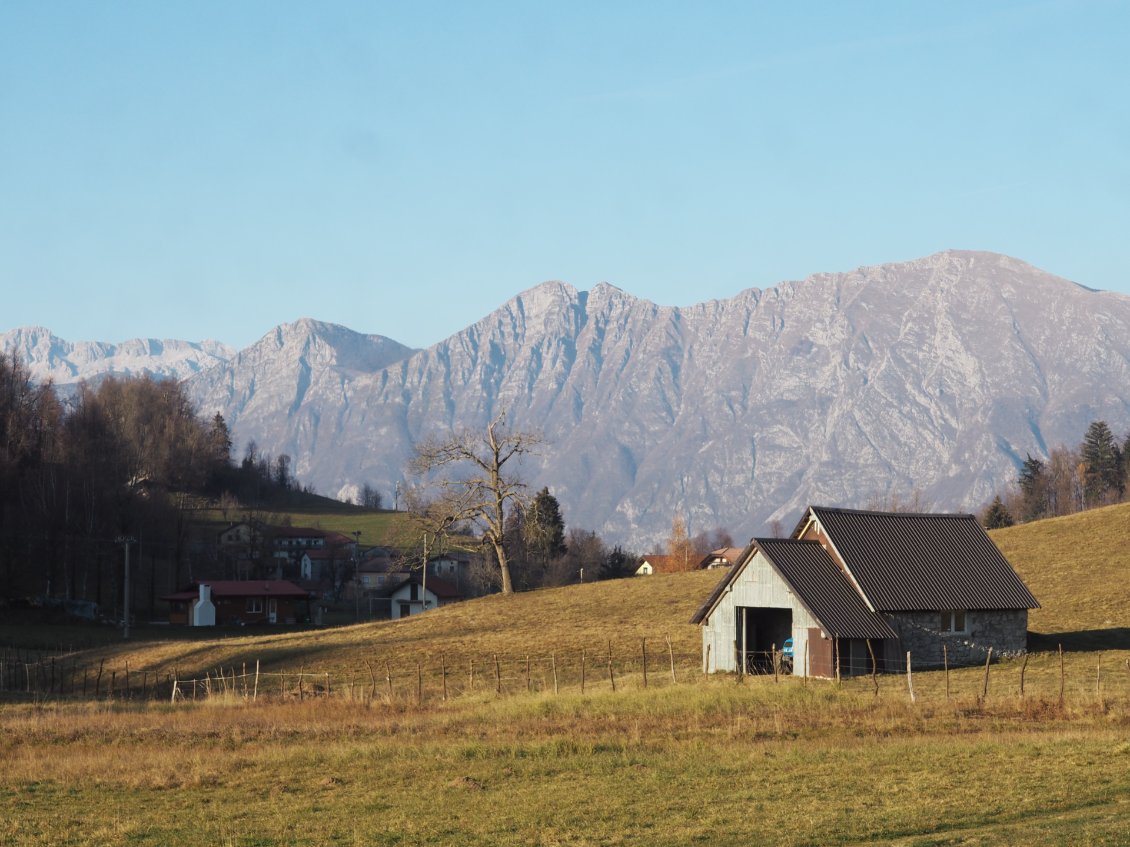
[0,0,1130,347]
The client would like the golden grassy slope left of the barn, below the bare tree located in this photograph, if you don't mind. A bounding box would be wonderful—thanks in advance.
[75,571,719,673]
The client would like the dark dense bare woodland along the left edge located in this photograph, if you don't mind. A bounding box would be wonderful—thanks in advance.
[0,353,301,617]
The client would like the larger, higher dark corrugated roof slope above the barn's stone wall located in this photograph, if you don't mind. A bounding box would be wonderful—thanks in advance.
[811,506,1040,612]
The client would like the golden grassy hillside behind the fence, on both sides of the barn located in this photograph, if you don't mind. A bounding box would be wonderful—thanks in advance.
[26,504,1130,686]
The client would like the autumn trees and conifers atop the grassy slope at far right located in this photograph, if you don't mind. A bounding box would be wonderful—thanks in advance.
[982,420,1130,530]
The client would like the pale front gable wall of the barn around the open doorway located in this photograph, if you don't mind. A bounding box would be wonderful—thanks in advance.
[703,551,819,675]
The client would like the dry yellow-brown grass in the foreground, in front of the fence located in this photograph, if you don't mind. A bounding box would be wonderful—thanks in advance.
[0,678,1130,845]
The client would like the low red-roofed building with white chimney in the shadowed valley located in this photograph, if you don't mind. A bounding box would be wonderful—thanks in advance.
[162,579,310,627]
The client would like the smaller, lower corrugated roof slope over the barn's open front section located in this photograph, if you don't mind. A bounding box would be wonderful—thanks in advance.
[755,539,897,638]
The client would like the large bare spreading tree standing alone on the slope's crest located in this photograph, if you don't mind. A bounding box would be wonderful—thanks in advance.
[408,412,545,594]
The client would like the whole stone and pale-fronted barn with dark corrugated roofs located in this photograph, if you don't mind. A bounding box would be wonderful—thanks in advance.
[692,506,1040,676]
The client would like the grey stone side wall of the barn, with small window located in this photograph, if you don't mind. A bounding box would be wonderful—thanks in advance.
[885,609,1028,667]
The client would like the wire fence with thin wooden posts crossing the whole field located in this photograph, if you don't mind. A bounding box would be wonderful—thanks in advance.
[0,637,1130,706]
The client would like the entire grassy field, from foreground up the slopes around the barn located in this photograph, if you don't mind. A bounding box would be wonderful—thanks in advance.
[0,507,1130,847]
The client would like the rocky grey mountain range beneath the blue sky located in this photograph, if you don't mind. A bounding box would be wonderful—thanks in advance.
[0,251,1130,549]
